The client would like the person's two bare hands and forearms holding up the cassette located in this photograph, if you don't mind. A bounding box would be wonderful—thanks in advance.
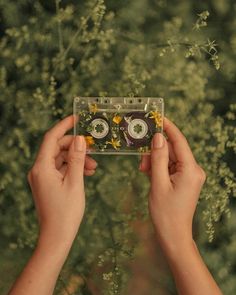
[9,116,222,295]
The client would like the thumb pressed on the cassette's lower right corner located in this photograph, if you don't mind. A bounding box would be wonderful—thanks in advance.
[151,133,171,192]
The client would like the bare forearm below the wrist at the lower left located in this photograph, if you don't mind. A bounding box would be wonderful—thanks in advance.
[9,237,71,295]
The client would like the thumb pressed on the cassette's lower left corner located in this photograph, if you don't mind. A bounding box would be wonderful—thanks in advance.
[66,136,86,185]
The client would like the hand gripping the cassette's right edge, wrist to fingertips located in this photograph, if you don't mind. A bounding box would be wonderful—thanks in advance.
[140,118,206,249]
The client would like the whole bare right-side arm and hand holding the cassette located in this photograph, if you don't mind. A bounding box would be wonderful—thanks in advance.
[140,118,222,295]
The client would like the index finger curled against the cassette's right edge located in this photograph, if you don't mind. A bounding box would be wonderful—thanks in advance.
[164,117,195,164]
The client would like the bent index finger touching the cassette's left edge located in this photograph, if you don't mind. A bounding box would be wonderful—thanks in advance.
[37,115,76,160]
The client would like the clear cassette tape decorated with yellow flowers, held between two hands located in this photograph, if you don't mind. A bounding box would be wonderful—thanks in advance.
[74,97,164,154]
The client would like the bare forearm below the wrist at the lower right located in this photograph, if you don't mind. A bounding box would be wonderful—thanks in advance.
[159,239,222,295]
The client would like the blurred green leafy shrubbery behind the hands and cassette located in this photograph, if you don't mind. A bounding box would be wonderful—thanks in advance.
[0,0,236,295]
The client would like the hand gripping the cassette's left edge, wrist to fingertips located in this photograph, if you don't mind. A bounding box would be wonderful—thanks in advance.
[28,115,97,244]
